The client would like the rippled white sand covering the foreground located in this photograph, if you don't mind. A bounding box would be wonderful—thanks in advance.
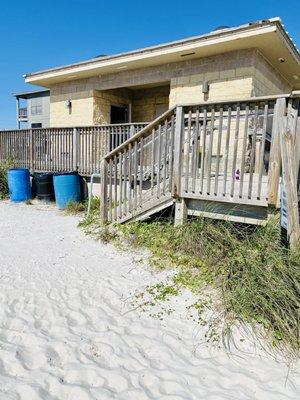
[0,202,300,400]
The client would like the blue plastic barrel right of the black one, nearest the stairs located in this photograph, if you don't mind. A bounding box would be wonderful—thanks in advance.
[53,174,81,210]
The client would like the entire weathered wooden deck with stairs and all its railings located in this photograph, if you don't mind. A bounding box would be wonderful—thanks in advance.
[0,94,300,232]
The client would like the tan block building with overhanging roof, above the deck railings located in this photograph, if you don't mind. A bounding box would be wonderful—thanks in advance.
[25,18,300,127]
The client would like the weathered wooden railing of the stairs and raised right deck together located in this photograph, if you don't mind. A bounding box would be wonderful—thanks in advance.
[101,95,300,231]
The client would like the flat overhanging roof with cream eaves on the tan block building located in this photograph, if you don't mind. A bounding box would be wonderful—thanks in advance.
[24,18,300,89]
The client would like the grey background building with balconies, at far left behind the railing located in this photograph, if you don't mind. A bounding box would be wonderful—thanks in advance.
[13,90,50,129]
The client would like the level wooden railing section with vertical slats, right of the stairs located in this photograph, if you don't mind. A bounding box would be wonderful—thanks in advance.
[180,99,275,204]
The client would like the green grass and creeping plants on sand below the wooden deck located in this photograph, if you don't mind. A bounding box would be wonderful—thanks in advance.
[80,216,300,357]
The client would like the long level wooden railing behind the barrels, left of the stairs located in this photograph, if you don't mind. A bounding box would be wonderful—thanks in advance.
[0,123,147,175]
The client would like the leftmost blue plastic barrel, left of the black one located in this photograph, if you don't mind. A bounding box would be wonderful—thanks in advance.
[7,168,31,202]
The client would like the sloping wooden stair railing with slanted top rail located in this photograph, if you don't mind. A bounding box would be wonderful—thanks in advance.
[100,108,176,221]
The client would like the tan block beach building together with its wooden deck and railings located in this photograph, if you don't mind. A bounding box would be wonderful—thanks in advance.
[0,18,300,228]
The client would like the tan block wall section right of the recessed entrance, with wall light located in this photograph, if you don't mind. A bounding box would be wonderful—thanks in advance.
[170,49,291,106]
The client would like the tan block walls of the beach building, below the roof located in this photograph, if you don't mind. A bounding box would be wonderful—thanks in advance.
[50,49,290,126]
